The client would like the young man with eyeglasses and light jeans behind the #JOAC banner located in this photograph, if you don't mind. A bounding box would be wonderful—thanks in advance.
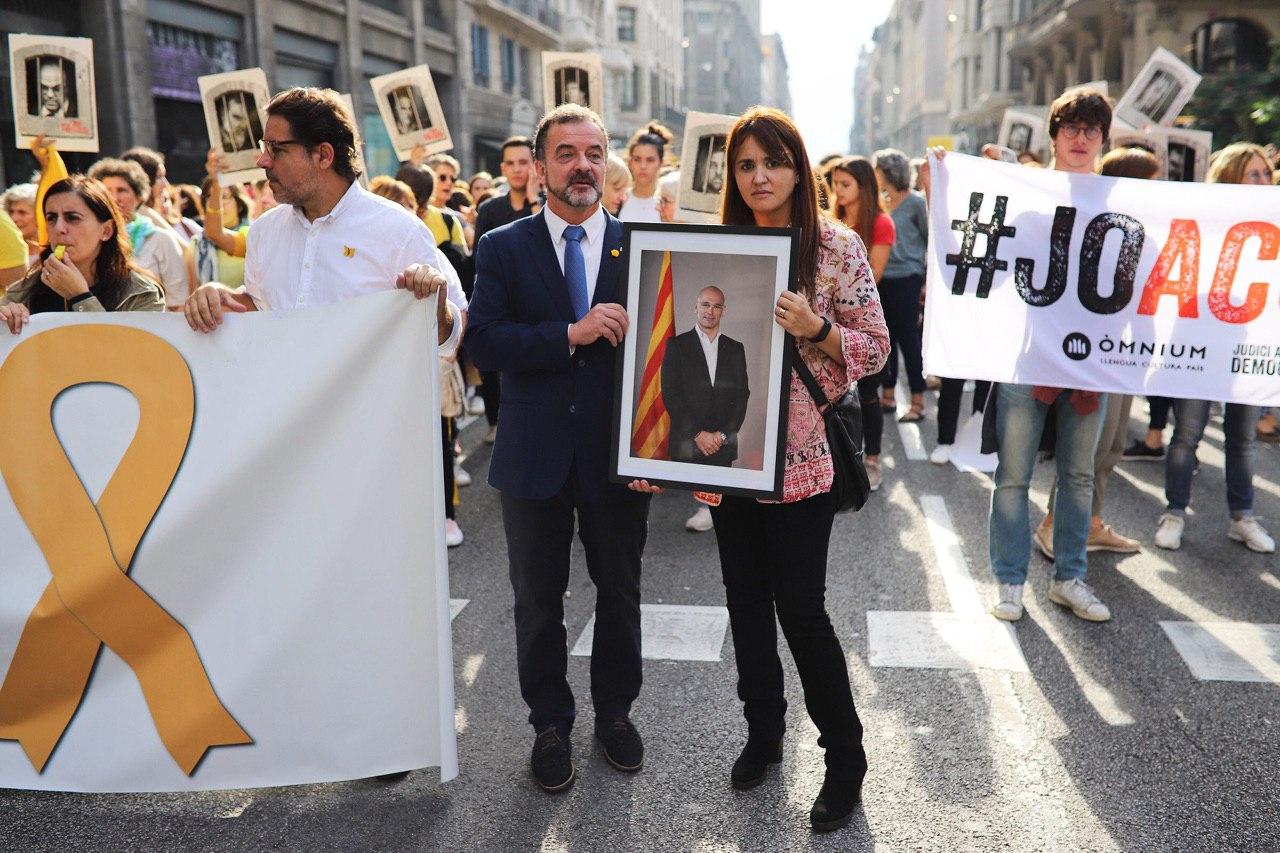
[987,88,1111,622]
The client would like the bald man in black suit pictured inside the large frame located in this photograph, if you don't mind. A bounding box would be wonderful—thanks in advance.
[662,286,751,467]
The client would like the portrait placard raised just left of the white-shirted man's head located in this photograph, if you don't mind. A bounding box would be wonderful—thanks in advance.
[196,68,271,187]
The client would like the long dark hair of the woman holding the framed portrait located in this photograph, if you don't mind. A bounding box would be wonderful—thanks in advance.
[721,106,822,297]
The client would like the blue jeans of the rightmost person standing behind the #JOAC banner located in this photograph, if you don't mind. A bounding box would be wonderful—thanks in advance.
[1165,400,1260,519]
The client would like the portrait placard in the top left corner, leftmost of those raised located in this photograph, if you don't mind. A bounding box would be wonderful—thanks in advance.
[9,33,99,151]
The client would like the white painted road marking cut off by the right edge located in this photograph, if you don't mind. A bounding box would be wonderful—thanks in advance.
[1160,621,1280,684]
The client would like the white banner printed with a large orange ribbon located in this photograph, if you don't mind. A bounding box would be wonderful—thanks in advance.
[0,292,457,792]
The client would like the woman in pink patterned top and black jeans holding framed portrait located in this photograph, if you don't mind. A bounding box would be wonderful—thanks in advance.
[712,108,890,831]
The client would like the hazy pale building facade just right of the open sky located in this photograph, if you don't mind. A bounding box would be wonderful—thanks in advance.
[849,0,951,155]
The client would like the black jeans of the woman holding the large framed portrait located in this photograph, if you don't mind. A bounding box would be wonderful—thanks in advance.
[712,492,867,780]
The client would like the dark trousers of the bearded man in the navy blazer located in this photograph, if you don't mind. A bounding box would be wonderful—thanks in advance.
[502,471,649,736]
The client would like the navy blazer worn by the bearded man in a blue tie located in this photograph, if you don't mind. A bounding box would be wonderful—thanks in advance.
[463,213,640,502]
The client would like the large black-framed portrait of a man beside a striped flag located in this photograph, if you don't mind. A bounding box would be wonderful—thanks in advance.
[609,223,799,500]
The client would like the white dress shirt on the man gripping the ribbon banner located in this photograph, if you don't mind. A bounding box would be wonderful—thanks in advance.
[244,182,467,353]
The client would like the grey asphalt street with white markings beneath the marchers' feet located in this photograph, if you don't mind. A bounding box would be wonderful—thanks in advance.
[0,391,1280,852]
